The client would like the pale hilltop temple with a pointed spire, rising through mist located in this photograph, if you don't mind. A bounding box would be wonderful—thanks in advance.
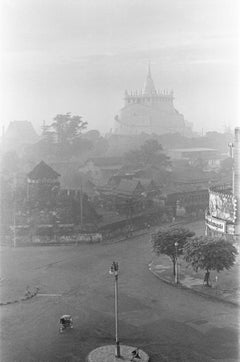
[115,66,191,135]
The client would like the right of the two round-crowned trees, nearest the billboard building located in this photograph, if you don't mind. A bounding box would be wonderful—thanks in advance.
[183,236,238,286]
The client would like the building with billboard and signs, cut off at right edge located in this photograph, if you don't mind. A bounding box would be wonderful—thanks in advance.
[205,128,240,240]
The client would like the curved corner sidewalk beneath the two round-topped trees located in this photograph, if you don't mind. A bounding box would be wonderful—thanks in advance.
[149,255,240,305]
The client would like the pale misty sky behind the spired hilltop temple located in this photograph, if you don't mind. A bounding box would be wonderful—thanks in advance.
[0,0,239,132]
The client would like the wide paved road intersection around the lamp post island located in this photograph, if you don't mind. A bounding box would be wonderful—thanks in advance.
[1,230,239,362]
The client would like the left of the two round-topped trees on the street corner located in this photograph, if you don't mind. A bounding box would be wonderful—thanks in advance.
[152,226,195,276]
